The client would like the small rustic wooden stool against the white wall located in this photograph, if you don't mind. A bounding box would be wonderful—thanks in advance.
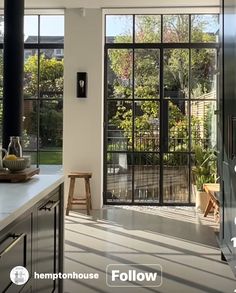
[66,172,92,216]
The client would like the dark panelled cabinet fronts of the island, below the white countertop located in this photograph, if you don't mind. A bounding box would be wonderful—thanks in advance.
[0,176,64,293]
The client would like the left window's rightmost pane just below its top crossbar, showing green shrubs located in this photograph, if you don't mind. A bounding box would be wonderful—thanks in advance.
[39,49,64,99]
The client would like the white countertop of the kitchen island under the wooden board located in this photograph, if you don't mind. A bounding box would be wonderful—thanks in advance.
[0,175,64,230]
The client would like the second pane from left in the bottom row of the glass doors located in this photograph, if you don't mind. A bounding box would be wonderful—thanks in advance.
[134,153,160,203]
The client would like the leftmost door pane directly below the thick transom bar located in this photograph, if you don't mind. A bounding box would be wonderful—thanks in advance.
[107,49,133,99]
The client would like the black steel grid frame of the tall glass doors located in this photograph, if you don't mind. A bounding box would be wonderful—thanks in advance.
[103,13,220,206]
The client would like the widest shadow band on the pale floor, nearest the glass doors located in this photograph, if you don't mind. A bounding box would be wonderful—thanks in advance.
[69,207,219,248]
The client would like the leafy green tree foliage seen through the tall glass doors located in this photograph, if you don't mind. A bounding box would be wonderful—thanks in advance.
[109,15,217,150]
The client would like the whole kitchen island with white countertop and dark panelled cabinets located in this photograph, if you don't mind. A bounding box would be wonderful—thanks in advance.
[0,175,64,293]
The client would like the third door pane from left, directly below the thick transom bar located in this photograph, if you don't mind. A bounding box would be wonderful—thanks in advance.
[164,49,189,99]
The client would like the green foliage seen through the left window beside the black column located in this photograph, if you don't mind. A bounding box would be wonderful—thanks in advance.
[24,54,63,147]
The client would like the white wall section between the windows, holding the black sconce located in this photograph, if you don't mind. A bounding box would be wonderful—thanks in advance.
[63,9,103,209]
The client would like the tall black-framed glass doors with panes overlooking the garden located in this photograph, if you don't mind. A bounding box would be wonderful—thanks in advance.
[104,15,218,205]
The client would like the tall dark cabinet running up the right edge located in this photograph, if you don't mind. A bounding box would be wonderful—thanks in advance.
[218,0,236,276]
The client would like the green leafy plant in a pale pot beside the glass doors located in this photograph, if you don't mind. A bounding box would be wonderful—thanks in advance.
[192,146,217,212]
